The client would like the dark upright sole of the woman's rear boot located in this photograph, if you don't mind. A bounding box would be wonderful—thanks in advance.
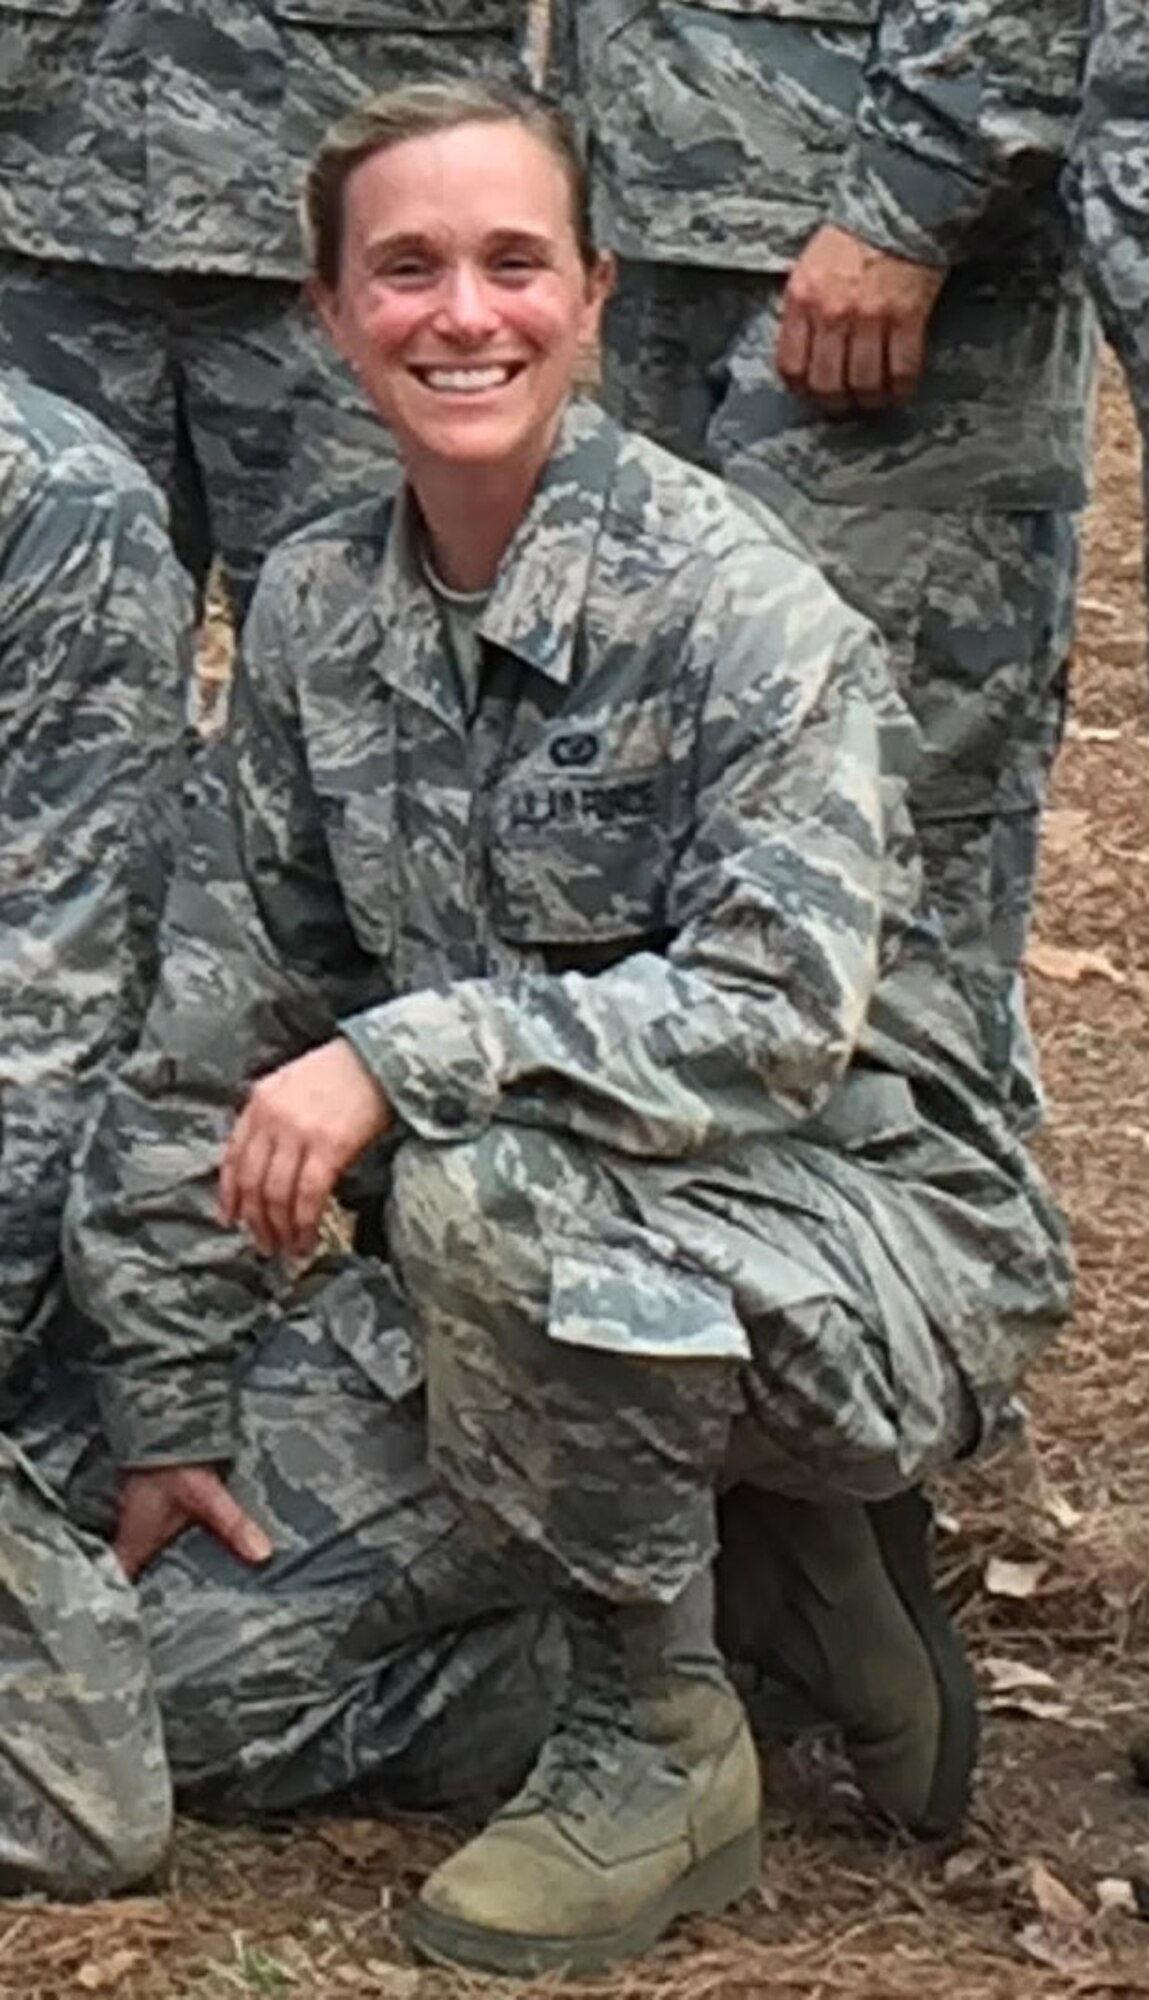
[867,1488,981,1840]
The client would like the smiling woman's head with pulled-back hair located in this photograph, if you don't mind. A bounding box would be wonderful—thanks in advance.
[306,118,609,482]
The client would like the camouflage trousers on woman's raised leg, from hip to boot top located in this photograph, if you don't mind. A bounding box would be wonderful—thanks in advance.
[390,1126,985,1602]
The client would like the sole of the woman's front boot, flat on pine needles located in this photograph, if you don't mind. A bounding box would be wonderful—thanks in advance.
[400,1826,763,1978]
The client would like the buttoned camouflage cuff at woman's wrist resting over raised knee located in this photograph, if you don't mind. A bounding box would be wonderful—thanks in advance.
[340,986,502,1146]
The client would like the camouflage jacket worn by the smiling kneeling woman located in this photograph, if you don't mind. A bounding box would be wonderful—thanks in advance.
[72,404,1065,1462]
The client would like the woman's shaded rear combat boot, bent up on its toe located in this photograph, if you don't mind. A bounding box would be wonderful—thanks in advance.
[719,1484,979,1838]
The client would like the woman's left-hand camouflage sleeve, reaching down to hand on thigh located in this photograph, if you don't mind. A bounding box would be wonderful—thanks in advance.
[66,558,382,1466]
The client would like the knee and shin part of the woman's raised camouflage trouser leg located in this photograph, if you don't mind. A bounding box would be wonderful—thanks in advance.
[388,1132,735,1598]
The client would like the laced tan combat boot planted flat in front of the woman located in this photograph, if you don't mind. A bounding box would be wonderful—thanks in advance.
[406,1578,761,1974]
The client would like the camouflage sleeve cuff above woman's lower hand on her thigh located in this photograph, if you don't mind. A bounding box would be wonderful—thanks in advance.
[98,1368,240,1470]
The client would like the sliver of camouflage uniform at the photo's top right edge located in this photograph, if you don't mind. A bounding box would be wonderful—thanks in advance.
[1071,0,1149,588]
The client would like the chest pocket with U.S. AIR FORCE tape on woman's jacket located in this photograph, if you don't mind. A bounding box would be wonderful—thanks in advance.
[488,770,671,952]
